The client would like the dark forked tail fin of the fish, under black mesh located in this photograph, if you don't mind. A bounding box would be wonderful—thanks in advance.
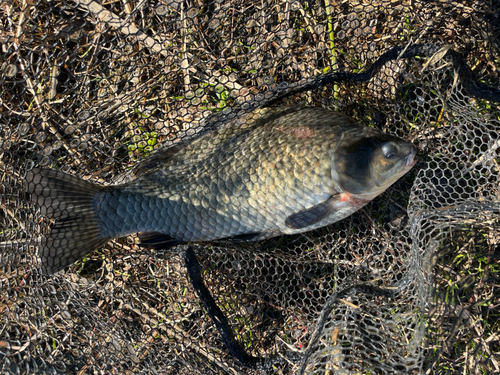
[25,168,110,274]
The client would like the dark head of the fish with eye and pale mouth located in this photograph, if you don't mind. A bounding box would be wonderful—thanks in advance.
[332,128,417,200]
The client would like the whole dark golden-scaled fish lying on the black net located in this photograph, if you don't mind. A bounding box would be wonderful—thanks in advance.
[25,107,417,274]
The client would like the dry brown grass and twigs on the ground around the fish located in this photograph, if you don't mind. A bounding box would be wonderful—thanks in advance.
[0,0,500,374]
